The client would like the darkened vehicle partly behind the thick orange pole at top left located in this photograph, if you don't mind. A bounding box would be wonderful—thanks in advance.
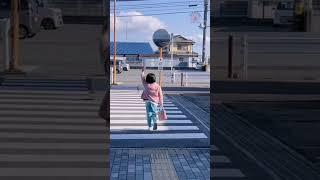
[0,0,41,39]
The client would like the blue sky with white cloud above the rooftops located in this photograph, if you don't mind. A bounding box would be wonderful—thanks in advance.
[110,0,210,59]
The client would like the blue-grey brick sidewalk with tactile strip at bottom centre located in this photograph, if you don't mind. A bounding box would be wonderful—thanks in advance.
[110,148,210,180]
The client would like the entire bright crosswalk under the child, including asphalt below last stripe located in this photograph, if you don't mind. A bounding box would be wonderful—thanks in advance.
[110,89,208,147]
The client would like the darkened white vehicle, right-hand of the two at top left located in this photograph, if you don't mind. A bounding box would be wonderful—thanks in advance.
[36,0,63,30]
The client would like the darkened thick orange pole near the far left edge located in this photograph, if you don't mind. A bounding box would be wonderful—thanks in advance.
[8,0,21,73]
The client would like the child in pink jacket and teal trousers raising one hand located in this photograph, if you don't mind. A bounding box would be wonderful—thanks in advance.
[141,68,163,131]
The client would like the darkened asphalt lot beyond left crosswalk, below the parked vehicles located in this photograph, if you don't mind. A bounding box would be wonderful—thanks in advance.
[0,24,104,77]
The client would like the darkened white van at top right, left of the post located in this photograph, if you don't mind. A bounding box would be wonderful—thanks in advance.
[273,0,294,26]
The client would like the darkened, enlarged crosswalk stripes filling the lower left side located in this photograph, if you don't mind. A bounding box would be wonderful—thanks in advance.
[0,79,109,180]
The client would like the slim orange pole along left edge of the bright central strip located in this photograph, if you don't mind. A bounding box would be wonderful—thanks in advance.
[112,0,117,85]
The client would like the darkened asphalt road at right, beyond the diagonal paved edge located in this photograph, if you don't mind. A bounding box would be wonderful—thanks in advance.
[213,81,320,176]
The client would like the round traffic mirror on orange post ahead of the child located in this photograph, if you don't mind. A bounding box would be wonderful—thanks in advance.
[153,29,171,86]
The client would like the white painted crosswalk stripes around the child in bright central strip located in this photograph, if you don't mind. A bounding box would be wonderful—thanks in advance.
[110,90,208,140]
